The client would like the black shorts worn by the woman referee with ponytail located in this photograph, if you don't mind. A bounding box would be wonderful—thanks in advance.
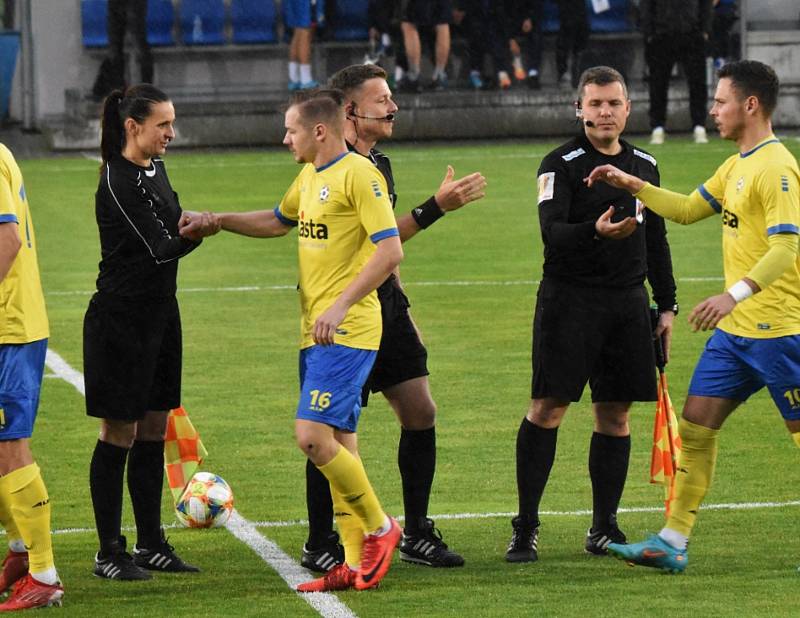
[83,293,182,421]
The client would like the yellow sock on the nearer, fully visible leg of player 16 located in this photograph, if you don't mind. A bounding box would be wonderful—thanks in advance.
[317,446,386,532]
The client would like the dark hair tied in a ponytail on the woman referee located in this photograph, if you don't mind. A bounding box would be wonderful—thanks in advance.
[100,84,169,169]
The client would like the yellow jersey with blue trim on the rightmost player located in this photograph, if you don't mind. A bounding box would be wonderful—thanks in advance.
[699,135,800,338]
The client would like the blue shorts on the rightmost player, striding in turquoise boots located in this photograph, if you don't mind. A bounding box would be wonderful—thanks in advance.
[689,329,800,421]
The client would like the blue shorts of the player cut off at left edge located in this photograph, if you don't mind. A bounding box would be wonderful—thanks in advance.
[0,339,47,441]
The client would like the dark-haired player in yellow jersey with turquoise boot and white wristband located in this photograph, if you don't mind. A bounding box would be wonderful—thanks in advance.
[587,60,800,573]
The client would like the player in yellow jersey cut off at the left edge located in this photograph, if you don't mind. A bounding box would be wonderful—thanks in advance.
[0,144,64,612]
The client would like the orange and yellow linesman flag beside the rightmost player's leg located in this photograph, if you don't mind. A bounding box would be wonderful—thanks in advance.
[650,369,681,517]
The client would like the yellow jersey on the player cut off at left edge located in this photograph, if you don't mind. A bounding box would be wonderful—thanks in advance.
[0,144,50,344]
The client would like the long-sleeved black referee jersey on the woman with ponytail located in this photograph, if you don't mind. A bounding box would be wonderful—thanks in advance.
[95,156,200,300]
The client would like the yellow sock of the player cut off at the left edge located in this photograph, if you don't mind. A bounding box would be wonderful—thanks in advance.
[0,463,55,574]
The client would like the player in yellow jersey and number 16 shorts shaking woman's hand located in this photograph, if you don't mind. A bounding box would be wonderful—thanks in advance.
[181,89,403,592]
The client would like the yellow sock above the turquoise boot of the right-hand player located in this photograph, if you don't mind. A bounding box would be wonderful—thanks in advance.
[666,418,719,537]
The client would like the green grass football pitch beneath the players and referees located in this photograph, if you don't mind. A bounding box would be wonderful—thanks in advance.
[21,137,800,617]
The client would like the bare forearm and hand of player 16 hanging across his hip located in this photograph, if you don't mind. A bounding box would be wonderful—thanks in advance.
[314,236,403,345]
